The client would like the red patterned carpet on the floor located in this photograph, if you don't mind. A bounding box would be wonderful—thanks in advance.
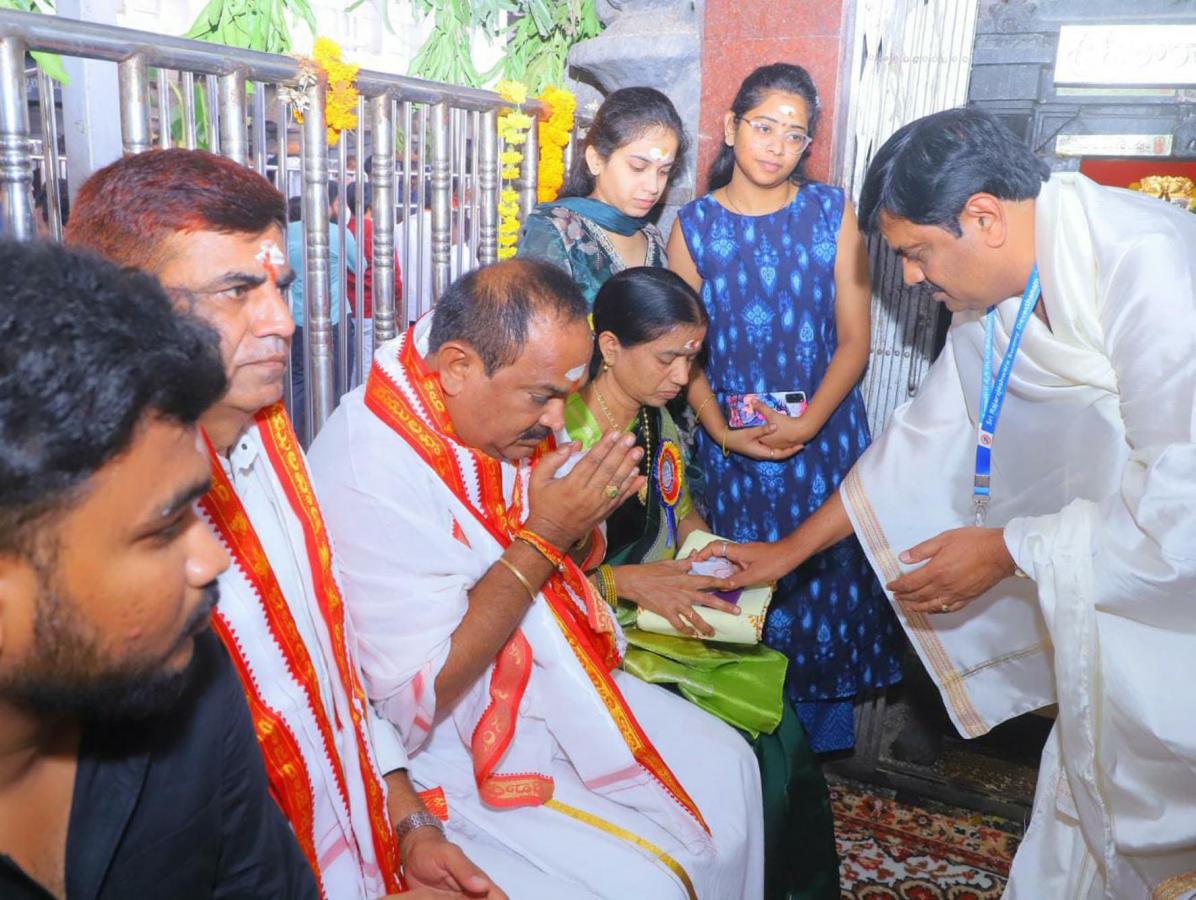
[830,779,1021,900]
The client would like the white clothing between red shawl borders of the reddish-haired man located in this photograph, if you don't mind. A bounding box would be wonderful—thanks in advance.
[206,427,407,900]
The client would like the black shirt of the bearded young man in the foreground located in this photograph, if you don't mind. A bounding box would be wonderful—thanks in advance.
[0,631,319,900]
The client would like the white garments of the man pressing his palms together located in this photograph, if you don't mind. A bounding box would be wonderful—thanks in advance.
[303,342,763,900]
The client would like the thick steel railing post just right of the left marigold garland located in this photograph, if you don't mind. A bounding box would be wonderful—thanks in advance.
[368,93,397,347]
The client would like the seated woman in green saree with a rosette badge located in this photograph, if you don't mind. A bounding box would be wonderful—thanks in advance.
[561,268,838,900]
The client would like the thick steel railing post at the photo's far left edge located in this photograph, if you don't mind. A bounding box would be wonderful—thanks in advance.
[0,37,34,240]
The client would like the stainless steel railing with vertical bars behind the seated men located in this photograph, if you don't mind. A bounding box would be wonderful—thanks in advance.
[0,11,572,442]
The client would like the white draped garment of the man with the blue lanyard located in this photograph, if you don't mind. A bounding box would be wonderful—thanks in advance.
[842,175,1196,900]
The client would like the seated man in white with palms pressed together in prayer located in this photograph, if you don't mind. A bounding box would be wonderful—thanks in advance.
[311,259,763,900]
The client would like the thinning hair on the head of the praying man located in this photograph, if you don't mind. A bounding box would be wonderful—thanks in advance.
[428,259,590,375]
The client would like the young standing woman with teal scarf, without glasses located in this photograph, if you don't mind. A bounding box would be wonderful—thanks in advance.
[518,87,689,304]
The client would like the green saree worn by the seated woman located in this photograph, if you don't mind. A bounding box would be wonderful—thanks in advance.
[565,394,840,900]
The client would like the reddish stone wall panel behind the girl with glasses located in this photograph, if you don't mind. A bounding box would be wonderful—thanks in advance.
[696,0,850,196]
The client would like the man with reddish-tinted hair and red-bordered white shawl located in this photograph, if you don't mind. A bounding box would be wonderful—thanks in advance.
[66,149,504,900]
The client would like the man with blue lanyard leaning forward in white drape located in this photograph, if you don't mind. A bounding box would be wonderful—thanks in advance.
[703,110,1196,900]
